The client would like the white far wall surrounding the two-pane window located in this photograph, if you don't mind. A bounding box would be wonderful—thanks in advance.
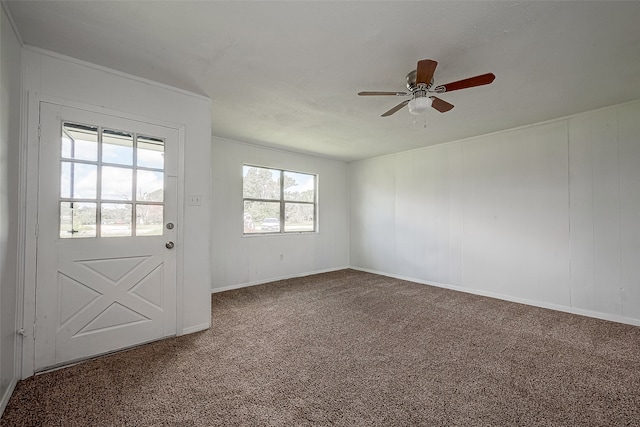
[211,138,349,292]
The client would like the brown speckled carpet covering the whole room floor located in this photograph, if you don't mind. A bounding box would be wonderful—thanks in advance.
[1,270,640,426]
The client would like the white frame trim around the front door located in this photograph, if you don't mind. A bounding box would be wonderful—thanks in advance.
[17,92,185,379]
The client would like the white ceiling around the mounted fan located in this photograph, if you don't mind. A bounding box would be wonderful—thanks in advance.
[6,1,640,161]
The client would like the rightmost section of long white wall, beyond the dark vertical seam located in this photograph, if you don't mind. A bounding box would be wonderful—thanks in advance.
[569,103,640,320]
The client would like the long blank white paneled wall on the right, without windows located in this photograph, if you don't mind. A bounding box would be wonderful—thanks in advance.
[350,102,640,324]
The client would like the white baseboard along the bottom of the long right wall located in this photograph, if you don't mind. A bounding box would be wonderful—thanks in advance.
[349,266,640,326]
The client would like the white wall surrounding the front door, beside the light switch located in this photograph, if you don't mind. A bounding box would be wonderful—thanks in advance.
[23,48,211,376]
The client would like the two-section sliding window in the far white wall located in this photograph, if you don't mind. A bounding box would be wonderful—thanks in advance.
[242,165,318,234]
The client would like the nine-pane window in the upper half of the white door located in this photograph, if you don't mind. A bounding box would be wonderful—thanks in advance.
[59,122,164,239]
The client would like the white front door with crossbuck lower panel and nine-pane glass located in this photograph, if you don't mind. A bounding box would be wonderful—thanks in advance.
[35,102,179,371]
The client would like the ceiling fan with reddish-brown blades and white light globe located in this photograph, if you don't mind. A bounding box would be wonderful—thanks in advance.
[358,59,496,117]
